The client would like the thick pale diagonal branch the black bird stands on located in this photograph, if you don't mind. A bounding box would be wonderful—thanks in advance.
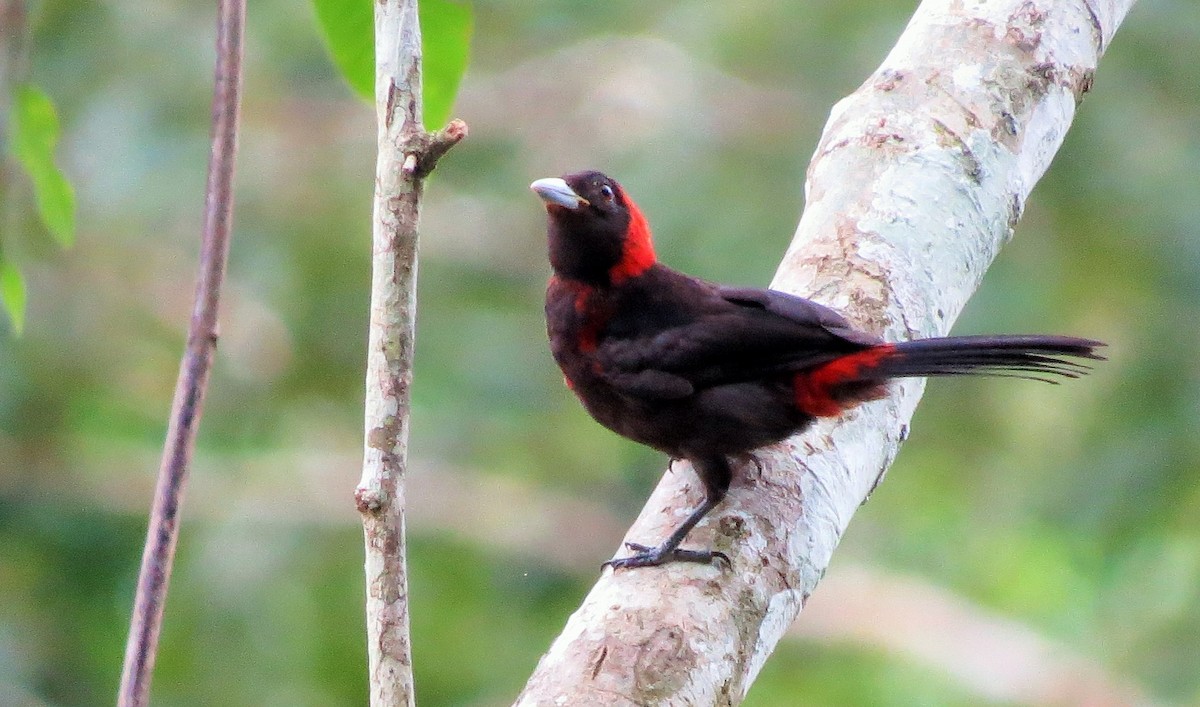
[517,0,1133,706]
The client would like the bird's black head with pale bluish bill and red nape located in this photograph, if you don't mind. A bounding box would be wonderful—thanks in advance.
[529,172,655,284]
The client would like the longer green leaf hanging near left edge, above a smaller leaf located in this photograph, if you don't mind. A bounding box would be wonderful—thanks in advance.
[8,84,74,247]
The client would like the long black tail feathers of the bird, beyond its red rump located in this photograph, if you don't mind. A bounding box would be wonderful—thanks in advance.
[870,335,1104,383]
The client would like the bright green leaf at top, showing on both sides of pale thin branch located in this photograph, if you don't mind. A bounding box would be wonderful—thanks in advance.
[313,0,473,127]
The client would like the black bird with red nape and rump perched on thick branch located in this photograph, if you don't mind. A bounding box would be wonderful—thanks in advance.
[529,172,1103,569]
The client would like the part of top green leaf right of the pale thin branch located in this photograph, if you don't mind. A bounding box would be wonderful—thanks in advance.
[418,0,472,130]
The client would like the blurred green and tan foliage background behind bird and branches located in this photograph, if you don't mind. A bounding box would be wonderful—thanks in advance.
[0,0,1200,706]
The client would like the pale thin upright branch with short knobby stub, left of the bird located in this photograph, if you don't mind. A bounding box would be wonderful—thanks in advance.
[355,0,467,706]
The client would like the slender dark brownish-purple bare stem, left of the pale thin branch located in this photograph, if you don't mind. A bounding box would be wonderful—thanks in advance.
[118,0,246,707]
